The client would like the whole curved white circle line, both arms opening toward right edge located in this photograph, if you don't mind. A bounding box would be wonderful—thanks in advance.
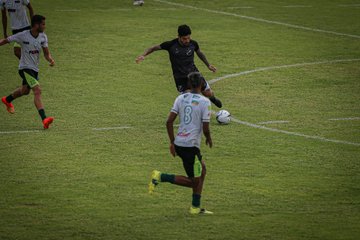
[208,59,360,146]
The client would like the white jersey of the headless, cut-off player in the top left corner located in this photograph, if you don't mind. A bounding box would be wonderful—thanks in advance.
[0,0,30,30]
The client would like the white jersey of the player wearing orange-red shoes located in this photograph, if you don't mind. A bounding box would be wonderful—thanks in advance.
[7,30,48,72]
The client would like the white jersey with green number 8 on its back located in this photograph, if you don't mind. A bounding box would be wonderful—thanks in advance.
[171,93,211,149]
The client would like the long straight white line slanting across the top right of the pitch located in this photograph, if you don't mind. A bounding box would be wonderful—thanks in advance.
[154,0,360,39]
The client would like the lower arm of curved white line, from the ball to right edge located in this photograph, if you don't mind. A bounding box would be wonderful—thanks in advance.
[231,117,360,146]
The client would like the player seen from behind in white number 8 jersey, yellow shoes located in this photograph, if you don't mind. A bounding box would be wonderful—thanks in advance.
[149,72,212,214]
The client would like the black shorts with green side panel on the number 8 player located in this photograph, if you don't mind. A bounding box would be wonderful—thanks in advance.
[175,145,202,178]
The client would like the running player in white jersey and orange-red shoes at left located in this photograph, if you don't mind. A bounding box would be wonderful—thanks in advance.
[0,15,55,129]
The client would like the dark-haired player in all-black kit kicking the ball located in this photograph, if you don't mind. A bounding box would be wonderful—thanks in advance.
[136,25,222,108]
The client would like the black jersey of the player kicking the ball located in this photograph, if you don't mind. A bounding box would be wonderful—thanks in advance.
[160,38,199,79]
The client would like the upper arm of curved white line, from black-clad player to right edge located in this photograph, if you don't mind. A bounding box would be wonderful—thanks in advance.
[208,58,360,84]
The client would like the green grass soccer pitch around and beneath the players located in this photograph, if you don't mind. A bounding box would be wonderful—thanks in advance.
[0,0,360,240]
